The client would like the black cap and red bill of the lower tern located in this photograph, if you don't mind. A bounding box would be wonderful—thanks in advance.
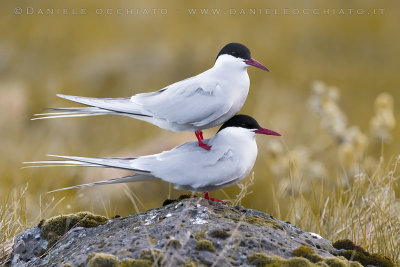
[218,114,281,136]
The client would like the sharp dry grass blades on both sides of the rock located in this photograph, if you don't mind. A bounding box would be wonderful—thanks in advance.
[0,161,400,265]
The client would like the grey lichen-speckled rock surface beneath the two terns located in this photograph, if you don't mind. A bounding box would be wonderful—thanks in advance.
[9,198,356,266]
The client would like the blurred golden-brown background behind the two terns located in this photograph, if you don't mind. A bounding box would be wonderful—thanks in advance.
[0,0,400,226]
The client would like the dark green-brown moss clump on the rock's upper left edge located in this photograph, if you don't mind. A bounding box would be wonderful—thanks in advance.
[38,212,108,247]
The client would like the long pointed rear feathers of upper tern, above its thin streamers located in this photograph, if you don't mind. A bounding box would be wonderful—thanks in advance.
[57,94,152,117]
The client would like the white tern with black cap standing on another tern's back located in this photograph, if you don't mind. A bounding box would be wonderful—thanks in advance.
[33,43,269,150]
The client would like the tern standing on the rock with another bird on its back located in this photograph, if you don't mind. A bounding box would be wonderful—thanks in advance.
[25,115,280,200]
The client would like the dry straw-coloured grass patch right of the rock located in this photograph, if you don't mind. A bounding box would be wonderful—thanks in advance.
[276,157,400,264]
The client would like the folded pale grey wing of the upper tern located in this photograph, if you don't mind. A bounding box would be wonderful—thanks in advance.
[131,75,232,127]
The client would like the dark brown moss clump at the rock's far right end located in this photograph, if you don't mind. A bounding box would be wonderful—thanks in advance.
[333,239,395,267]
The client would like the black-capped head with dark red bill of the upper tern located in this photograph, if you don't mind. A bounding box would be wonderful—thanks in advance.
[216,43,269,71]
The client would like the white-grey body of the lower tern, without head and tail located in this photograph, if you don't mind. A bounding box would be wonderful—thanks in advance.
[132,128,257,192]
